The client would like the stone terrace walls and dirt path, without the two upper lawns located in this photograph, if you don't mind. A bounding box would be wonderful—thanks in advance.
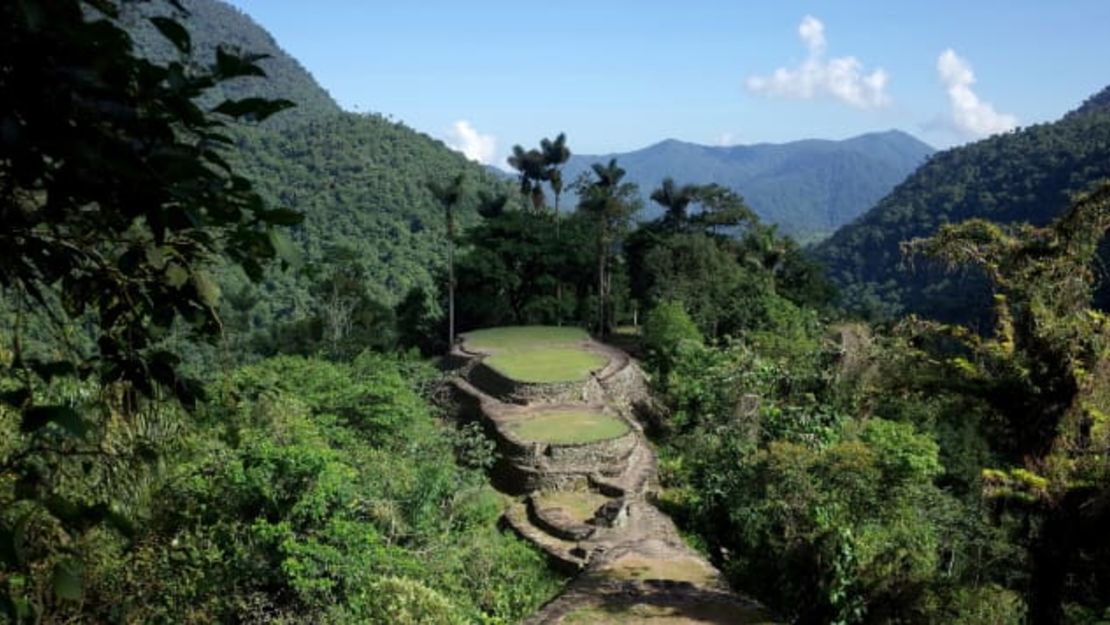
[452,341,774,625]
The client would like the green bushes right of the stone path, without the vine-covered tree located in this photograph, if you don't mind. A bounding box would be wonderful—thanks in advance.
[654,315,1029,624]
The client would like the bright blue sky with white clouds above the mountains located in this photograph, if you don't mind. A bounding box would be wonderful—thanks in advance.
[225,0,1110,163]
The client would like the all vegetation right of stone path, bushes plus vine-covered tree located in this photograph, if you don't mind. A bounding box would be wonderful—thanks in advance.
[646,187,1110,624]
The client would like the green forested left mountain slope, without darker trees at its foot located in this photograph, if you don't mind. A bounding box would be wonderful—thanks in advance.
[123,0,511,310]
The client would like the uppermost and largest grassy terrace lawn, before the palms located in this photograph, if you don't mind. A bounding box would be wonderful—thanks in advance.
[465,325,607,384]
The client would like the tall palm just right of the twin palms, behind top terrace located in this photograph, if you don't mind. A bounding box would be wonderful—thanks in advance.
[576,159,640,335]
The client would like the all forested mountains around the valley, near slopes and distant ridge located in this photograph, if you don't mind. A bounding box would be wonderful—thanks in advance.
[132,0,1110,333]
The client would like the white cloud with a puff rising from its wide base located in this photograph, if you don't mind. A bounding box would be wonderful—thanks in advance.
[747,16,890,109]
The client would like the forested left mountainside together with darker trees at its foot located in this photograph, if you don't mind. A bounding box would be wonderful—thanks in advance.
[121,0,519,366]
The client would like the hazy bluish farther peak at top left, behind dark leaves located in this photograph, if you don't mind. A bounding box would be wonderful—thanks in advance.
[121,0,340,128]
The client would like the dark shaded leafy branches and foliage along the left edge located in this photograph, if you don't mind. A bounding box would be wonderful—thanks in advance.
[0,0,301,618]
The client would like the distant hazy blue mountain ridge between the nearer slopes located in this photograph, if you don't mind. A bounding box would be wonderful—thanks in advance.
[564,131,932,239]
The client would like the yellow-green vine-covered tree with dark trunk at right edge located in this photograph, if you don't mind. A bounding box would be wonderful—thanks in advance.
[906,184,1110,623]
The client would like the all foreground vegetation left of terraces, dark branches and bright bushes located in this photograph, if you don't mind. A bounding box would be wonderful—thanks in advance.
[0,1,558,624]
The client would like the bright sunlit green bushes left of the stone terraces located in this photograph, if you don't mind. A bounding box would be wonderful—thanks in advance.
[0,354,557,623]
